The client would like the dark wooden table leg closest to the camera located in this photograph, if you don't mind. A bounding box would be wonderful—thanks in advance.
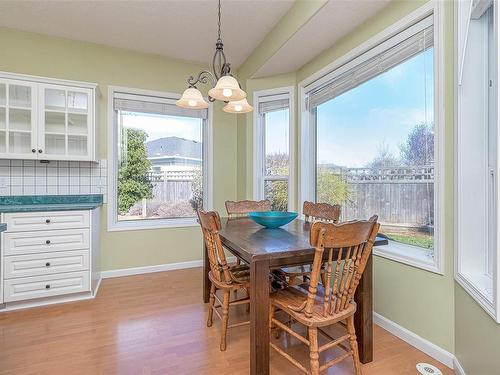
[250,260,269,375]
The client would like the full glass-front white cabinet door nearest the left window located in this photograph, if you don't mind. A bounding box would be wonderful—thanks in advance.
[38,85,93,160]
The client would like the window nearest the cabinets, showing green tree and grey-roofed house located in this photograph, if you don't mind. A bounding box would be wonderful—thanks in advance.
[109,89,210,229]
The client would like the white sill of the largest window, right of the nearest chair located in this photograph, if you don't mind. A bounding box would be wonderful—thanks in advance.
[373,241,444,275]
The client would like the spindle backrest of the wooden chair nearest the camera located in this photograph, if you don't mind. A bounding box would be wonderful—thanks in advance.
[301,215,380,317]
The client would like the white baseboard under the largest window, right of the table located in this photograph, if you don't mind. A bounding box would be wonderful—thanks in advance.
[373,312,458,369]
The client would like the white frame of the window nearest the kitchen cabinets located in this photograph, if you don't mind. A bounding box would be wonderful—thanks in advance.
[107,86,213,232]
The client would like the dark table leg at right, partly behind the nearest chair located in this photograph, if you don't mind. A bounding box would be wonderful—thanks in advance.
[354,255,373,363]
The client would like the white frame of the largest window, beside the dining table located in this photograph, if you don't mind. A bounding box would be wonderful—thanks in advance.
[298,0,445,275]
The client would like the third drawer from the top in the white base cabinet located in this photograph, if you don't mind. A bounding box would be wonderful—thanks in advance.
[4,250,90,279]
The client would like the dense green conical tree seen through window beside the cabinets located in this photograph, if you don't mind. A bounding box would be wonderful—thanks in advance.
[118,129,153,214]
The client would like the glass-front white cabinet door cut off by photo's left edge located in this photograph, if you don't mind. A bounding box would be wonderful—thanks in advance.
[0,79,38,159]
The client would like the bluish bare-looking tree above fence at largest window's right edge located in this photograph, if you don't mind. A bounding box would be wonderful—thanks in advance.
[399,123,434,165]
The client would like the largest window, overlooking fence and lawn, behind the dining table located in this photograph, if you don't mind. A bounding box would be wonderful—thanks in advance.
[301,4,442,272]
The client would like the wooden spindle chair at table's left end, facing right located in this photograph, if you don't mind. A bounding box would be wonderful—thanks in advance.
[198,210,250,351]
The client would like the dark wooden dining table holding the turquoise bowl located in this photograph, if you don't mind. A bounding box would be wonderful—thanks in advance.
[203,217,388,375]
